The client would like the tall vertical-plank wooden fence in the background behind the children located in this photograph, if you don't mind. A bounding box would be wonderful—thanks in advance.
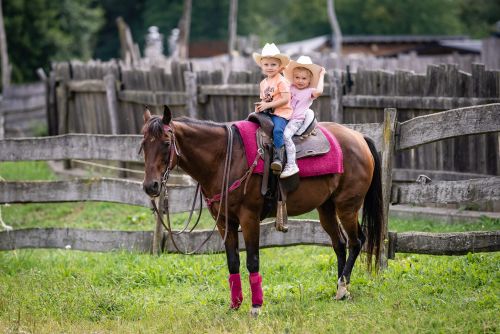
[44,62,500,177]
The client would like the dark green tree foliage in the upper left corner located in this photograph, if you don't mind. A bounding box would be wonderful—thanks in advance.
[2,0,103,82]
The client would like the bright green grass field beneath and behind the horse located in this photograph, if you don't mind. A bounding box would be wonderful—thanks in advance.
[0,163,500,333]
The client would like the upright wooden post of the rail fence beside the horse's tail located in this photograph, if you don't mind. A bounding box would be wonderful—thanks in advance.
[379,108,397,269]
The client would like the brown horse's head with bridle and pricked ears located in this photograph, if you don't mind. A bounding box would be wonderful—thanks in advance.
[141,106,176,197]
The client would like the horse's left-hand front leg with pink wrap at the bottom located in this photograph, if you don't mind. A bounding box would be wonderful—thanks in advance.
[217,218,243,309]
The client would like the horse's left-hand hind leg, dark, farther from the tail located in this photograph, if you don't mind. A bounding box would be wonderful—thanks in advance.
[318,200,347,278]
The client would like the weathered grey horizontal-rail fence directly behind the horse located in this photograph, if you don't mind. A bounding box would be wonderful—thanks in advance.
[0,104,500,261]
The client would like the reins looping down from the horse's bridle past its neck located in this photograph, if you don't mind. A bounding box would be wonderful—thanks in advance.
[151,125,261,255]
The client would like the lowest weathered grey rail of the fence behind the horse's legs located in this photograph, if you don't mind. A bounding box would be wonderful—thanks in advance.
[0,223,500,254]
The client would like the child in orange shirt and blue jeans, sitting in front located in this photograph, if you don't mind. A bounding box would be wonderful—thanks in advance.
[253,43,292,174]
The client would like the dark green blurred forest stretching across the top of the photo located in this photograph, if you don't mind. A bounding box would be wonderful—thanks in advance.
[3,0,500,82]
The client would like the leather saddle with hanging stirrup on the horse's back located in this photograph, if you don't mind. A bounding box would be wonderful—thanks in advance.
[247,112,330,232]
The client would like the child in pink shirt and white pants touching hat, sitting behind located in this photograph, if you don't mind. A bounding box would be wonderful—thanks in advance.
[280,56,325,178]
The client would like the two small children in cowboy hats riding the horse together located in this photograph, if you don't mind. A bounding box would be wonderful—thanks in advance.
[253,43,325,178]
